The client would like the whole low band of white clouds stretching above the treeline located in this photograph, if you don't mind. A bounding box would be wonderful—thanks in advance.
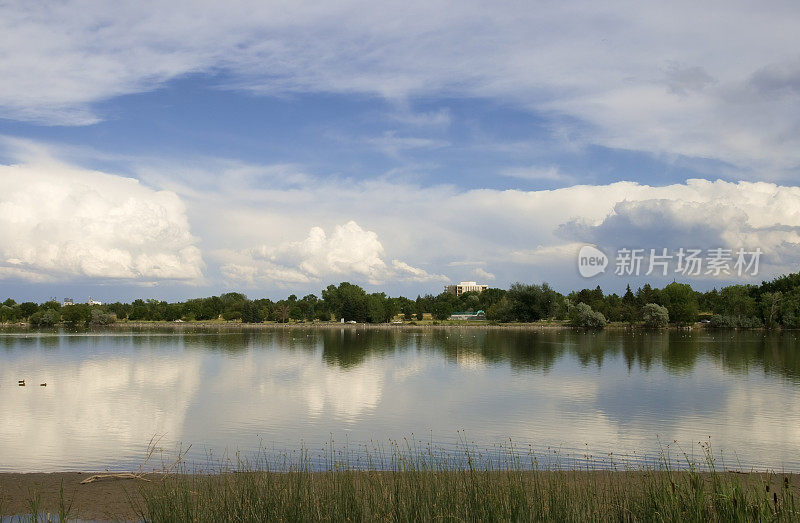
[6,142,800,292]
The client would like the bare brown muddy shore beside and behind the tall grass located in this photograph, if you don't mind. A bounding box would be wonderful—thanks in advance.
[0,470,800,521]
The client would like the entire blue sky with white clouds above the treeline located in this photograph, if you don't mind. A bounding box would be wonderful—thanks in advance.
[0,0,800,301]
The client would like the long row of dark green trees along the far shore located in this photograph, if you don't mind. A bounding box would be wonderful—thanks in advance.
[0,273,800,328]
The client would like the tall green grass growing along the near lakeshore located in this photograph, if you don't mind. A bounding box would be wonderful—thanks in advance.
[140,444,800,522]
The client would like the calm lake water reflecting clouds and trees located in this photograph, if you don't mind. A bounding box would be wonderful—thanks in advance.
[0,328,800,471]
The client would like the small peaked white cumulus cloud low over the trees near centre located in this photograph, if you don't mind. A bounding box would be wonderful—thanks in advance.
[221,221,447,284]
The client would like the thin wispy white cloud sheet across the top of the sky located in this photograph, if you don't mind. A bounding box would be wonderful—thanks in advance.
[0,0,800,176]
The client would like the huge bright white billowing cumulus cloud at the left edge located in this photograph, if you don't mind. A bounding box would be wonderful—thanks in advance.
[0,161,204,282]
